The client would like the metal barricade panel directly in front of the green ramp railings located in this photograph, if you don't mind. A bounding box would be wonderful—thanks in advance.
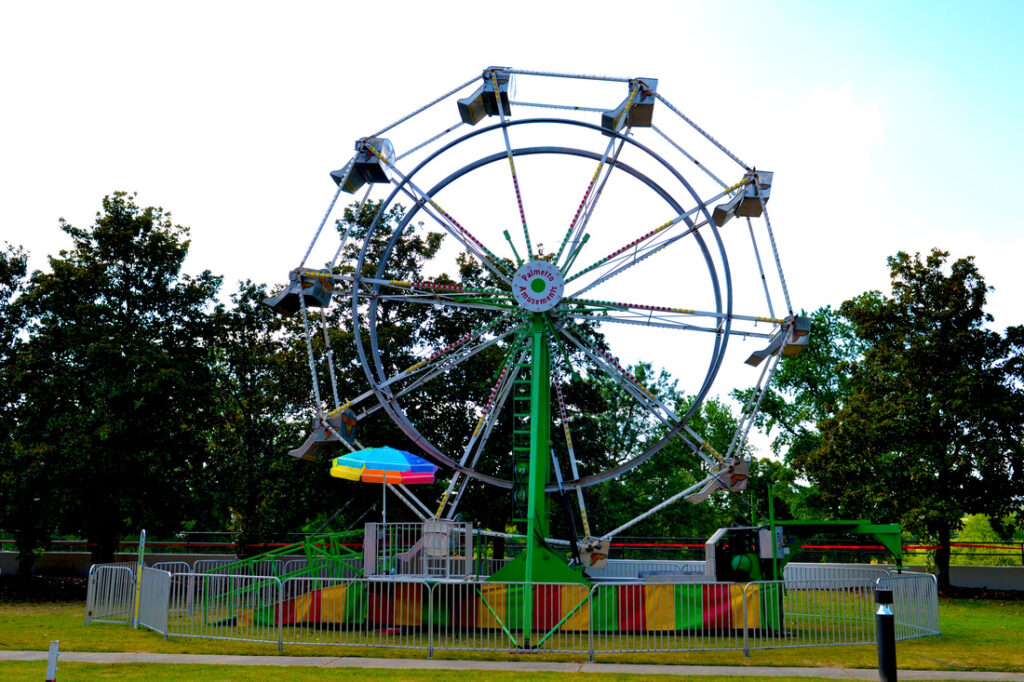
[168,573,282,646]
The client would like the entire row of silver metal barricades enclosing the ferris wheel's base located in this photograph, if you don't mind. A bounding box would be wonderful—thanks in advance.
[87,566,940,659]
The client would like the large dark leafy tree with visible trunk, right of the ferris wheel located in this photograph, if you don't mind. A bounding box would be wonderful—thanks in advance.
[794,250,1024,585]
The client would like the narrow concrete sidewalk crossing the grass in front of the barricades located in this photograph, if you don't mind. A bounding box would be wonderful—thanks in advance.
[6,651,1024,682]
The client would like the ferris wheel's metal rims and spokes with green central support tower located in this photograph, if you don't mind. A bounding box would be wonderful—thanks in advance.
[274,67,806,606]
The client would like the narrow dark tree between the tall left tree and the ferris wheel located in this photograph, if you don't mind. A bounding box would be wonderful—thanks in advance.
[199,282,328,556]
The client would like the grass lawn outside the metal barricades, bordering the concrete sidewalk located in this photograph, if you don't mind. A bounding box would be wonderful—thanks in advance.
[0,599,1024,680]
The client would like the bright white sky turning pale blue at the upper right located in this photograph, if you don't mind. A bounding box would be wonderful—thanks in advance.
[0,0,1024,450]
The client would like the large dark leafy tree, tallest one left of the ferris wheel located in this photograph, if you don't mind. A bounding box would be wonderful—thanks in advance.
[15,193,220,562]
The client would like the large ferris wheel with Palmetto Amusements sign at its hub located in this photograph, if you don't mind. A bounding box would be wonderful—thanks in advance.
[268,67,810,561]
